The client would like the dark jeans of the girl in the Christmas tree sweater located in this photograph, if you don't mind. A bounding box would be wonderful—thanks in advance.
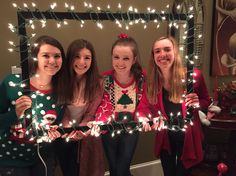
[102,132,139,176]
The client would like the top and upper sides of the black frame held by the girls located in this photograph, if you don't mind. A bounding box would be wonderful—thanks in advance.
[17,10,194,124]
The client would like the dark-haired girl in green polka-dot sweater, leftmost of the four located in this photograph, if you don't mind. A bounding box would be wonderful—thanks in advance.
[0,36,65,176]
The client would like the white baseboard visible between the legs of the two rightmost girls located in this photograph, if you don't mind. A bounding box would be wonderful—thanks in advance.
[105,160,163,176]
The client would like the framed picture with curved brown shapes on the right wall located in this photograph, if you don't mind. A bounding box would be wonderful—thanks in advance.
[210,0,236,76]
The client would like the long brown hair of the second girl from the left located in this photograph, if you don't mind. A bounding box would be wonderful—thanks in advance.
[58,39,101,104]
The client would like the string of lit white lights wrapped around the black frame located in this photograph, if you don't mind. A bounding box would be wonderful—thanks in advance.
[8,2,199,142]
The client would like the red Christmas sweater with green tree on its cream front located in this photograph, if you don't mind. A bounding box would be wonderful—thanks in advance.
[96,70,144,122]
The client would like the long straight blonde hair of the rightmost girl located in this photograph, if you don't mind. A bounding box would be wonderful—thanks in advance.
[147,36,186,104]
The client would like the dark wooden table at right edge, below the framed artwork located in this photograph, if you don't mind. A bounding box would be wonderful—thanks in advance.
[203,113,236,176]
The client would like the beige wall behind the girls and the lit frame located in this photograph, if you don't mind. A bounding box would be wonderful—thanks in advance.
[0,0,232,166]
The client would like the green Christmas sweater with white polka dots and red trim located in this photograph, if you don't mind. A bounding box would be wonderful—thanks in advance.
[0,75,63,167]
